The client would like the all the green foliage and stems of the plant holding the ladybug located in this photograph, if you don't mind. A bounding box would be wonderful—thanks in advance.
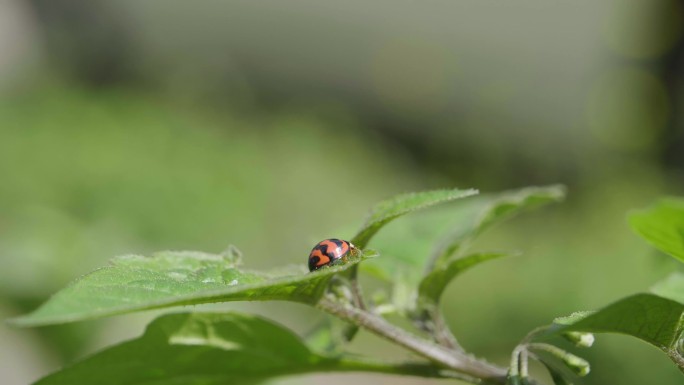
[10,186,684,385]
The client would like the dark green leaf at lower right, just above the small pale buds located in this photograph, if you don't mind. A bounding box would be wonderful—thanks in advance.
[554,294,684,352]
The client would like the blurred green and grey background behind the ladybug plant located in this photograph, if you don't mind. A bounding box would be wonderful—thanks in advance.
[0,0,684,384]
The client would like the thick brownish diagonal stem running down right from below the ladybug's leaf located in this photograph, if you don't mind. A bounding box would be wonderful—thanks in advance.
[318,297,506,384]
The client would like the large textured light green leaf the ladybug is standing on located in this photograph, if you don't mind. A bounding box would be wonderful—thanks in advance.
[10,248,374,326]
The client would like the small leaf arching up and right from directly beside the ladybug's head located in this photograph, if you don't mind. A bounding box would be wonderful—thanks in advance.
[352,189,478,249]
